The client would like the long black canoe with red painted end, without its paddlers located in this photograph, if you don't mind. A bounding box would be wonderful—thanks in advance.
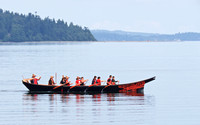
[22,77,155,93]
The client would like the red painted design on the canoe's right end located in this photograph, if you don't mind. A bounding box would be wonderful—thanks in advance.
[118,81,145,92]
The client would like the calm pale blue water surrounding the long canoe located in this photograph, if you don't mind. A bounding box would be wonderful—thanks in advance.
[0,42,200,125]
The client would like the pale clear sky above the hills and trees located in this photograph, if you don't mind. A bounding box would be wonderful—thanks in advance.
[0,0,200,33]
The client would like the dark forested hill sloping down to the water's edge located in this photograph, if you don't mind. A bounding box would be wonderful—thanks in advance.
[0,9,96,42]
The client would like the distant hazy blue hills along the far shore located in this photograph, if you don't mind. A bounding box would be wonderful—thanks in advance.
[91,30,200,41]
